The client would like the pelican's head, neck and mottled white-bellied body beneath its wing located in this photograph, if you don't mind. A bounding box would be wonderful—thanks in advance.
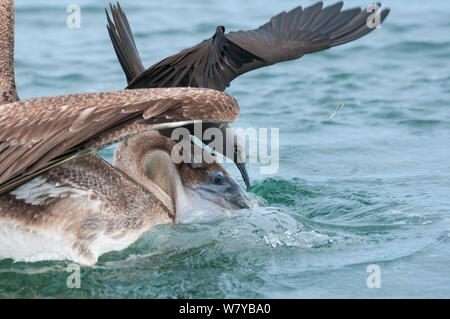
[0,131,246,265]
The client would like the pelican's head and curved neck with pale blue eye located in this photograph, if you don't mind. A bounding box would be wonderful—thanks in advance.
[114,132,248,220]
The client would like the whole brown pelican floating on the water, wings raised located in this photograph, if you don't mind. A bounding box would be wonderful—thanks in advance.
[0,0,247,264]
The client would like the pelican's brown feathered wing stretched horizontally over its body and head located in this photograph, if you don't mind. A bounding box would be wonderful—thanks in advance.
[0,88,239,194]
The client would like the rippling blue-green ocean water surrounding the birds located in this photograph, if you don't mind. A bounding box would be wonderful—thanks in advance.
[0,0,450,298]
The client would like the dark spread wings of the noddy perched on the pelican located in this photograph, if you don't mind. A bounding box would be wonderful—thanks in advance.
[107,1,389,91]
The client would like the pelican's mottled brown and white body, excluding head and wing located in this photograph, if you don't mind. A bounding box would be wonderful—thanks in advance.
[0,156,175,265]
